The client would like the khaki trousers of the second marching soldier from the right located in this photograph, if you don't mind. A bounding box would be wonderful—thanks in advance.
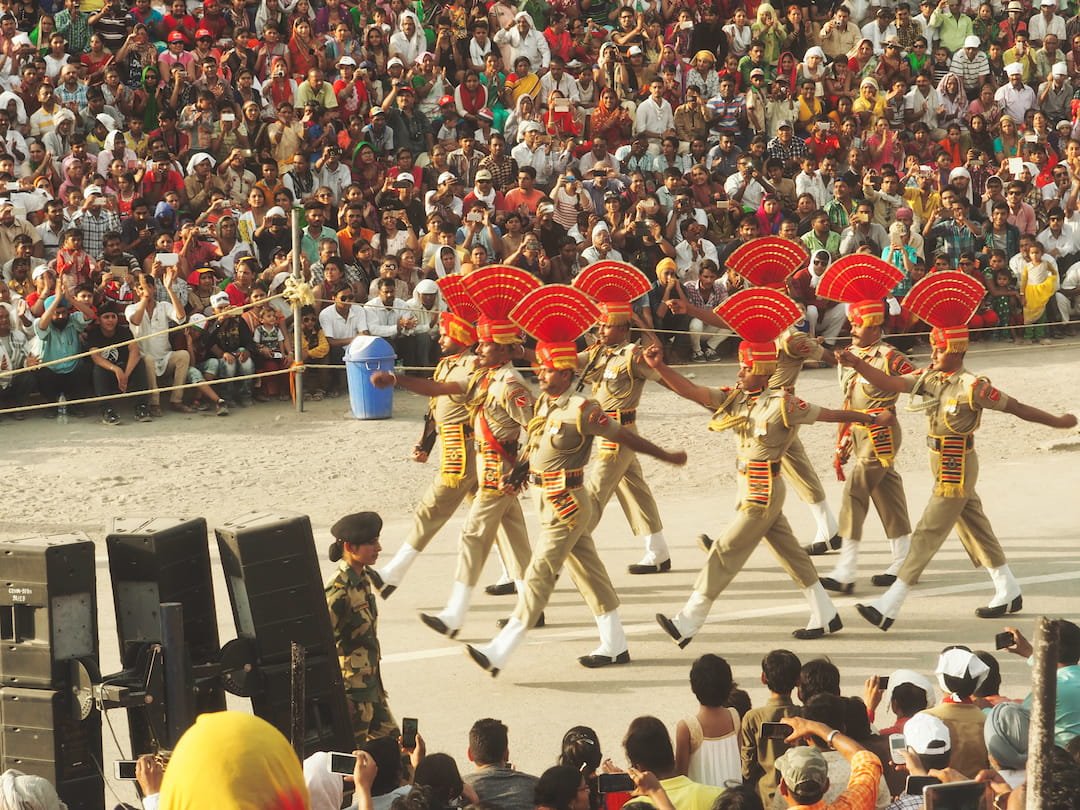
[838,426,912,540]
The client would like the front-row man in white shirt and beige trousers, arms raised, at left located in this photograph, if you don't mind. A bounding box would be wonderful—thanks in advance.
[124,270,191,416]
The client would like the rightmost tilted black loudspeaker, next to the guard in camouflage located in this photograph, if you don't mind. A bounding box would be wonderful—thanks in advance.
[215,512,353,755]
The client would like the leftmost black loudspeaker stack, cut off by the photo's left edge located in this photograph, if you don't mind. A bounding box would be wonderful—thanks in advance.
[0,534,105,810]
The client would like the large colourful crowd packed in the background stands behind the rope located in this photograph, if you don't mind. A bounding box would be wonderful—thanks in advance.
[6,0,1080,424]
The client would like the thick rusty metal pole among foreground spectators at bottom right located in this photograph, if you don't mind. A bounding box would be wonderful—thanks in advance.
[1027,616,1058,810]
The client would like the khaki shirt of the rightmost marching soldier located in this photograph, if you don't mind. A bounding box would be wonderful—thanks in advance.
[904,368,1009,436]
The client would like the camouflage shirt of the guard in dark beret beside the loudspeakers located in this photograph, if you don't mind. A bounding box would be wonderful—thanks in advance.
[325,561,382,702]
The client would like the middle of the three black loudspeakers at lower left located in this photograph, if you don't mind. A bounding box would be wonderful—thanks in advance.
[105,517,225,754]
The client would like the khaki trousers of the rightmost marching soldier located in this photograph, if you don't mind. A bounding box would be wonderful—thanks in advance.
[897,450,1008,585]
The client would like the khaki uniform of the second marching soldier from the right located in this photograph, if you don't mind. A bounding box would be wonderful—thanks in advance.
[839,342,915,540]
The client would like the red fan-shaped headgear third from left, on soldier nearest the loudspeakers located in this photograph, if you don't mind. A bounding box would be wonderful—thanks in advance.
[510,284,600,368]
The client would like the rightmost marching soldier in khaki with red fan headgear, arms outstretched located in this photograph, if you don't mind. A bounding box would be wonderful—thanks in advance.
[839,271,1077,630]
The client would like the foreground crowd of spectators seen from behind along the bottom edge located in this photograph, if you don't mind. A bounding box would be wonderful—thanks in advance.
[0,620,1080,810]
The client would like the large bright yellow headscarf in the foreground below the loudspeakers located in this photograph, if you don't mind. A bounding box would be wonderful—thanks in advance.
[159,712,310,810]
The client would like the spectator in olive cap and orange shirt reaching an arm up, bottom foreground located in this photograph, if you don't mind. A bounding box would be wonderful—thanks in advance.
[777,717,888,810]
